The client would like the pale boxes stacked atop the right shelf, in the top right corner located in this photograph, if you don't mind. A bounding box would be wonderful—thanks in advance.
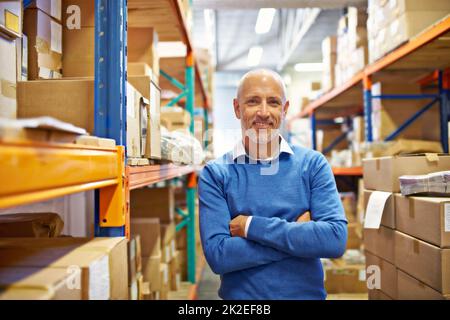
[367,0,450,63]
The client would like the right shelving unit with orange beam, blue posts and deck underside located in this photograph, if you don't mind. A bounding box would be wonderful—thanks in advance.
[291,16,450,158]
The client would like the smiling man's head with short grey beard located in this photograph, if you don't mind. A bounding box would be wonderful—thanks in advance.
[233,69,289,141]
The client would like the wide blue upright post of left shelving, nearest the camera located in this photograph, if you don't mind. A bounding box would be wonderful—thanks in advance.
[94,0,127,236]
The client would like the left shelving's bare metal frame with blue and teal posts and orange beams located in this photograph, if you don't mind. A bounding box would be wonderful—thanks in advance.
[95,0,208,283]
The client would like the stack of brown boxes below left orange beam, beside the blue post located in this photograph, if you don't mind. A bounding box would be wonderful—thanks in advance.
[131,187,181,299]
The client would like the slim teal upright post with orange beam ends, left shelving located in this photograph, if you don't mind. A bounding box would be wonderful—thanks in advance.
[185,51,196,283]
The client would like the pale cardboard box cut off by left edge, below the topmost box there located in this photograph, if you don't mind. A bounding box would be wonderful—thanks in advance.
[0,37,17,119]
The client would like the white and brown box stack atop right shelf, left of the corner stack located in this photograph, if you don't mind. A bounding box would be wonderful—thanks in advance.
[335,7,368,86]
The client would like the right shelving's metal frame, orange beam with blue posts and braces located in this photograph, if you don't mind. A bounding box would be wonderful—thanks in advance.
[291,17,450,159]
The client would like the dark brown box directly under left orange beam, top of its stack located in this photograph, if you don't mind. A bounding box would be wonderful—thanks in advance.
[131,186,175,224]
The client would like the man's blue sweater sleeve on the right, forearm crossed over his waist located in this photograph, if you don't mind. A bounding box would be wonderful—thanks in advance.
[247,154,347,258]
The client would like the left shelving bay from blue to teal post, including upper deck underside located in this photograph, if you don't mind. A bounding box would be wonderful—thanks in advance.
[95,0,208,283]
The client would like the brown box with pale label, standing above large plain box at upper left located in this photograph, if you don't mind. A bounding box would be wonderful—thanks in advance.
[23,9,62,80]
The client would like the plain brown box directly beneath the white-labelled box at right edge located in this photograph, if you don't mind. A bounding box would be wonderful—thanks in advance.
[395,231,450,294]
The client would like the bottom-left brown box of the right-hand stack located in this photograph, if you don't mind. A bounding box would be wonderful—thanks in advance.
[365,251,397,299]
